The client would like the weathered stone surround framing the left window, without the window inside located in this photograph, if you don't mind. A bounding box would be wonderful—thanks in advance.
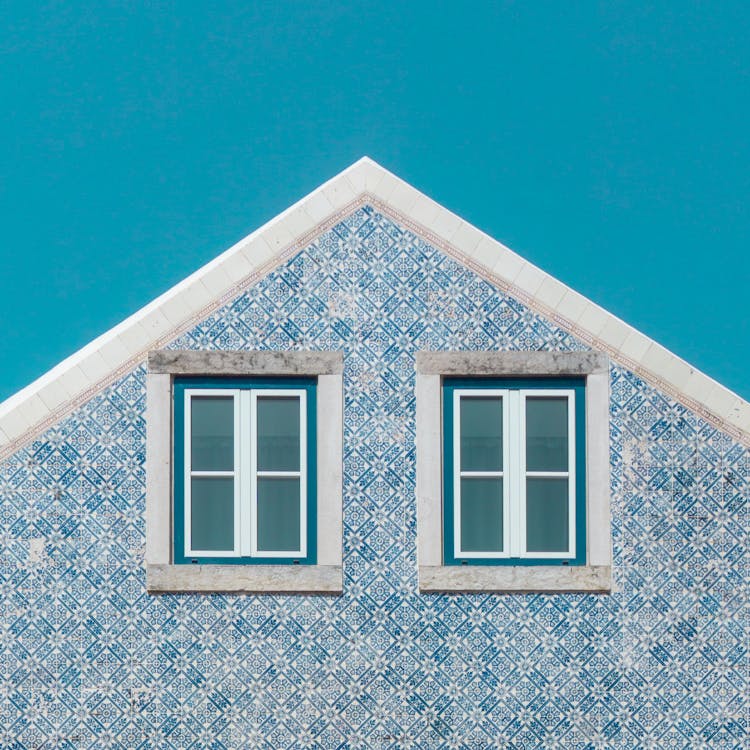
[146,349,344,594]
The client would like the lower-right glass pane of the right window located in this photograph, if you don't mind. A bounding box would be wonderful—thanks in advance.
[526,477,569,552]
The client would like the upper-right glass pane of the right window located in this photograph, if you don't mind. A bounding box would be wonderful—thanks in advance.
[526,396,568,471]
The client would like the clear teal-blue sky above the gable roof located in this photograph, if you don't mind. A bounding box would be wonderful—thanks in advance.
[0,0,750,400]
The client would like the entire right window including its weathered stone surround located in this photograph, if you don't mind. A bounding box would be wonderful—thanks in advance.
[417,352,611,592]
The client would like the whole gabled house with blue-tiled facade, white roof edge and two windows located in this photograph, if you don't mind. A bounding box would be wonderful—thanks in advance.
[0,159,750,750]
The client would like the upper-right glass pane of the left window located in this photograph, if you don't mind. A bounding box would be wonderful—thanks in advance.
[258,396,300,471]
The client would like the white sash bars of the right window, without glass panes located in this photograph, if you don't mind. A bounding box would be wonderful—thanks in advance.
[452,386,577,560]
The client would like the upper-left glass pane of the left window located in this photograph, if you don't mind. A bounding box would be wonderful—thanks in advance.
[190,396,234,471]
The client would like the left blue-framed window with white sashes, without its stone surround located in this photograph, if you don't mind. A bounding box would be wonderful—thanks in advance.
[173,377,317,565]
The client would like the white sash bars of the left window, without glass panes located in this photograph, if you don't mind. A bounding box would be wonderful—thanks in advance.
[183,387,308,559]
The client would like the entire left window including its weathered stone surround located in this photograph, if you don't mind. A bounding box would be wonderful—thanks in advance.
[146,350,343,593]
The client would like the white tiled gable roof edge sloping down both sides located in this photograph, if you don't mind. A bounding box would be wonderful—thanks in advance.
[0,157,750,459]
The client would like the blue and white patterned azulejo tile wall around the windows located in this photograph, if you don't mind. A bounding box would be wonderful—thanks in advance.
[0,207,750,750]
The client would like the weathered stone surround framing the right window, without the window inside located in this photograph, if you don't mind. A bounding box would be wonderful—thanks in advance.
[416,351,612,593]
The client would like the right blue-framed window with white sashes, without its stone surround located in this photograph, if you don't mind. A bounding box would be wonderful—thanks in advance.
[443,377,586,565]
